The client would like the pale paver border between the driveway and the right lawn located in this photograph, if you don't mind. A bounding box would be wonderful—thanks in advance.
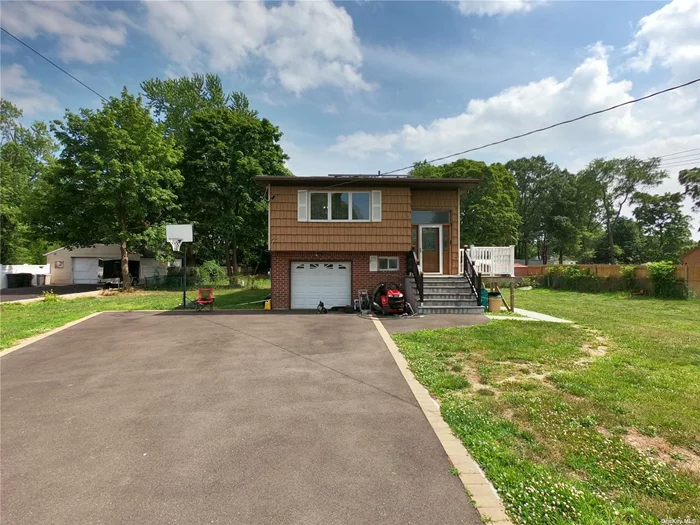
[372,318,512,525]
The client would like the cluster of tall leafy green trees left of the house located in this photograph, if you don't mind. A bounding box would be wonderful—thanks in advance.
[0,74,291,283]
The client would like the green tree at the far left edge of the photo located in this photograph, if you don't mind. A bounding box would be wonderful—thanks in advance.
[0,99,56,264]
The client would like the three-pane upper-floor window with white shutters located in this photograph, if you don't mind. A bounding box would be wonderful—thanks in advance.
[298,190,382,222]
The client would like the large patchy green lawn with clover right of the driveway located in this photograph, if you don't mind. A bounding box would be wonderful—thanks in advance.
[394,290,700,524]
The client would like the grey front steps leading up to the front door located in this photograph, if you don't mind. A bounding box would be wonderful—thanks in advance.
[411,275,484,314]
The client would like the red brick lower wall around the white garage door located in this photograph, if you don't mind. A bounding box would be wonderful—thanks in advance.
[270,252,406,309]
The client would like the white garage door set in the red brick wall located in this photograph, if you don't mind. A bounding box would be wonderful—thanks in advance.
[292,261,352,308]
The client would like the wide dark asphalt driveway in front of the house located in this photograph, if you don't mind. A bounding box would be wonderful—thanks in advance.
[0,312,480,525]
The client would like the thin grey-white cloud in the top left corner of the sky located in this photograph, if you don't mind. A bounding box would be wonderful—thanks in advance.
[2,1,129,64]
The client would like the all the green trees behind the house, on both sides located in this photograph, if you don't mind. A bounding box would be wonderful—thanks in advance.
[0,74,700,283]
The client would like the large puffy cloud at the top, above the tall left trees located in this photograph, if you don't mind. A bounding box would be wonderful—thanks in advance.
[145,0,371,94]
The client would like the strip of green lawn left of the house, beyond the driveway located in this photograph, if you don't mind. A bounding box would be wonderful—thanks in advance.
[0,279,270,349]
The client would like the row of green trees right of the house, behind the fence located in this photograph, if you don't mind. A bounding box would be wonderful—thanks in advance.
[410,155,700,264]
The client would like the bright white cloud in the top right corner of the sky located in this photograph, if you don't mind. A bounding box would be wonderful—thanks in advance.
[628,0,700,75]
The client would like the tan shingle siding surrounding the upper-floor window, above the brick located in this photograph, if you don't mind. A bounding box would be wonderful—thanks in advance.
[270,185,411,252]
